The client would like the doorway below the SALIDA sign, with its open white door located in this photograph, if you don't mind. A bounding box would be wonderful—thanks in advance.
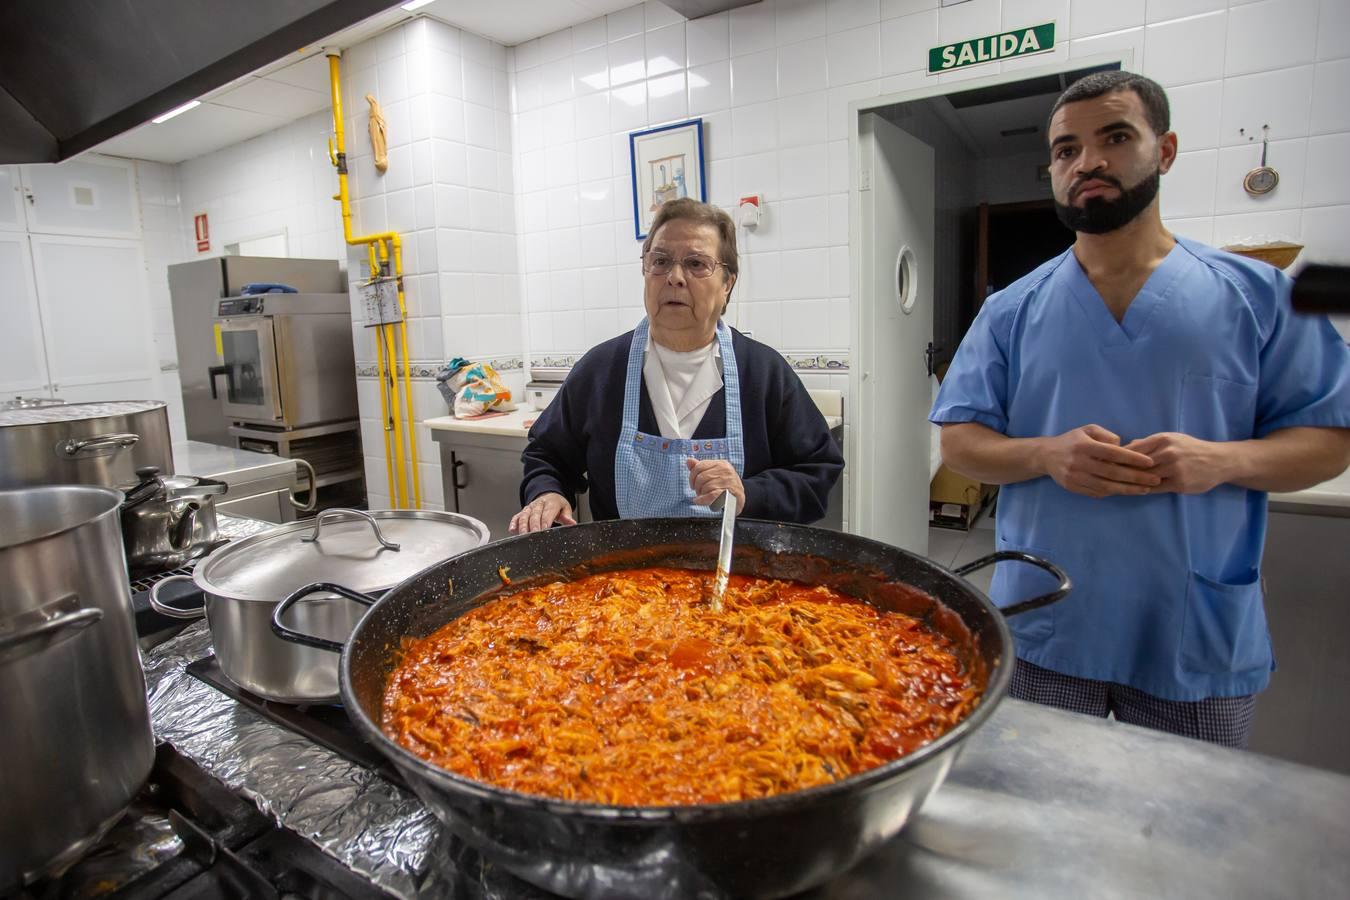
[845,51,1133,555]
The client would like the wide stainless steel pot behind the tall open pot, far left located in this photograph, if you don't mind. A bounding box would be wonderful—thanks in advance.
[0,401,173,490]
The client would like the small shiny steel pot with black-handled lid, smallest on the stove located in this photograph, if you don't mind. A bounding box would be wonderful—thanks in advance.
[122,466,230,579]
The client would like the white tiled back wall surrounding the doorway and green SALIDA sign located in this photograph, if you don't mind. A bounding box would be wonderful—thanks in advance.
[512,0,1350,369]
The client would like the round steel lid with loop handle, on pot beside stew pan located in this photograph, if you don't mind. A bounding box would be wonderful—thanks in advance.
[193,509,489,603]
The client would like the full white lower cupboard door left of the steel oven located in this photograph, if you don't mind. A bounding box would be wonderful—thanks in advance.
[32,235,159,399]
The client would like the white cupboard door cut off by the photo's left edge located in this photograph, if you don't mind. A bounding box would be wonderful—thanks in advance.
[0,232,51,399]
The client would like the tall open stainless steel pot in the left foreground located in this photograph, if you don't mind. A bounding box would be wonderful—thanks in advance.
[0,486,154,896]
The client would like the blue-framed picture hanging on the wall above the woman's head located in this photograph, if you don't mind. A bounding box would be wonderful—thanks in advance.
[628,119,707,240]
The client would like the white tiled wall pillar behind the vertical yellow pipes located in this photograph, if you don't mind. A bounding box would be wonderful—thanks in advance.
[340,19,525,509]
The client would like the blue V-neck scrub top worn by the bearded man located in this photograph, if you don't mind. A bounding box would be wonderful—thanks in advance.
[930,239,1350,700]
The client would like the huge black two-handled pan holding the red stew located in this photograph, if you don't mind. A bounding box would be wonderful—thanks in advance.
[273,518,1071,900]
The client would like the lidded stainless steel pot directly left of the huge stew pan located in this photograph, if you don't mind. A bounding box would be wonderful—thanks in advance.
[150,509,489,703]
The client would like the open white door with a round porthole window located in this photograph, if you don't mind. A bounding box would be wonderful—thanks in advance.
[849,113,934,555]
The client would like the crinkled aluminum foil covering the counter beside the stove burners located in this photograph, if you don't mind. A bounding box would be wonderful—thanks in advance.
[144,623,453,897]
